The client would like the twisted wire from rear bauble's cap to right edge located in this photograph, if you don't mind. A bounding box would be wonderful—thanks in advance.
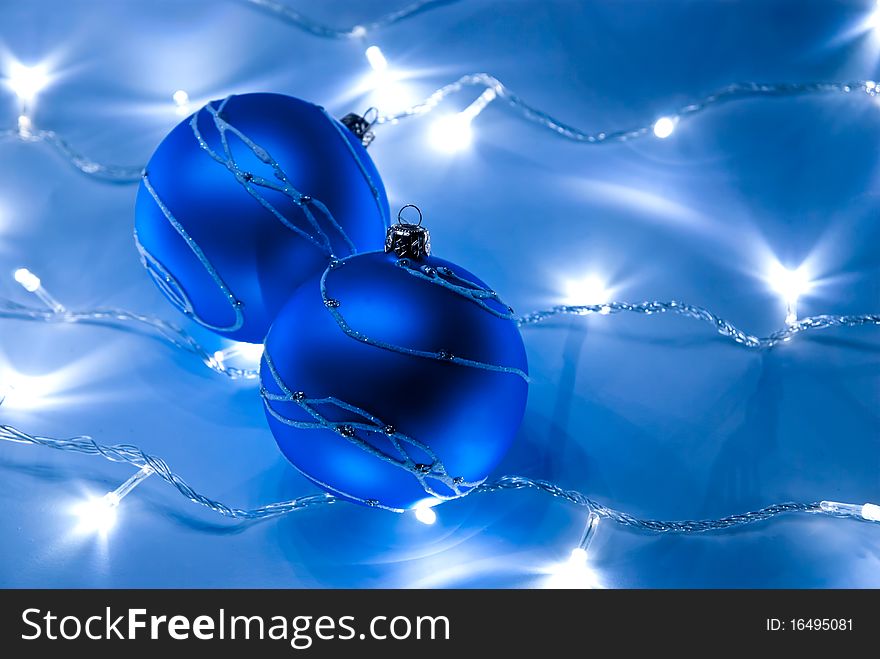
[376,73,880,144]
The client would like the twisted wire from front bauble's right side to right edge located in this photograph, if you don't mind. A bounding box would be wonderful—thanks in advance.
[517,300,880,350]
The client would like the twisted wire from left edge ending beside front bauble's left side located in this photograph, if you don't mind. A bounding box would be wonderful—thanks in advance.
[0,298,260,380]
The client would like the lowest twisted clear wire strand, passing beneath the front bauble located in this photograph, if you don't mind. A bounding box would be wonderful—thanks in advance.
[0,425,867,535]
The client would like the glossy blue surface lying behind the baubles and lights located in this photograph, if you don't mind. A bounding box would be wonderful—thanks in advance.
[0,0,880,587]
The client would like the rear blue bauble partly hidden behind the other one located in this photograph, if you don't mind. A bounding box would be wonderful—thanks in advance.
[135,94,388,342]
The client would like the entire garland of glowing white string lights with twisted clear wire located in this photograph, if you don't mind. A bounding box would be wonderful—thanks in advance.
[0,0,880,587]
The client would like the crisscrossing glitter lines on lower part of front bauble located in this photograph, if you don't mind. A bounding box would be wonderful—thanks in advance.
[260,352,483,512]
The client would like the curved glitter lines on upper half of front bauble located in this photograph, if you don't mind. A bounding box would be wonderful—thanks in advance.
[321,259,529,382]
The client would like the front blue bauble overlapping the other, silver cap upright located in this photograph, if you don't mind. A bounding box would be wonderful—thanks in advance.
[260,210,528,511]
